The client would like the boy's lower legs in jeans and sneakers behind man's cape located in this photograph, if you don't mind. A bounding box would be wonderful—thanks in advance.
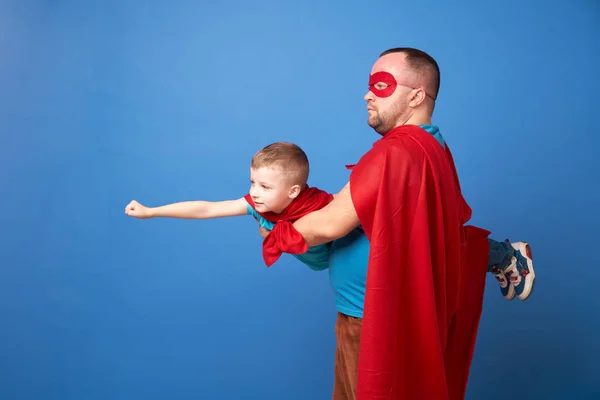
[488,239,535,300]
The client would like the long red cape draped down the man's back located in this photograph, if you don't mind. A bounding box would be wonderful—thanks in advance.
[350,126,489,400]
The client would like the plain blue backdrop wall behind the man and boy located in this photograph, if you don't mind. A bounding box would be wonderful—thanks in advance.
[0,0,600,400]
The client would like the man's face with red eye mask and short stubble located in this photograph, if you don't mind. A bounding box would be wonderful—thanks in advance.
[364,53,413,135]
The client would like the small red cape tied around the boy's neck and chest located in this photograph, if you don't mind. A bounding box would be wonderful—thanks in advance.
[244,186,333,267]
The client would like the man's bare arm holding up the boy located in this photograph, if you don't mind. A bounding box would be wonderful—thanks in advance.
[294,182,360,247]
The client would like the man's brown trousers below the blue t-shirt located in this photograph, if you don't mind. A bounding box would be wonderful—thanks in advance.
[332,312,362,400]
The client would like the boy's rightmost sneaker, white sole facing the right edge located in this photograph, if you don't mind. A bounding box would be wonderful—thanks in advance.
[504,241,535,301]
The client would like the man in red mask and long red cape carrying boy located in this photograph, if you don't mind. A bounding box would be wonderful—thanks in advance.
[262,48,512,400]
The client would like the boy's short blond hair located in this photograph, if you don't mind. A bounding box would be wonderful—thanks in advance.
[250,142,310,188]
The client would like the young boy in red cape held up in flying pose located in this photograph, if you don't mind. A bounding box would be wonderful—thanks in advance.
[125,142,535,300]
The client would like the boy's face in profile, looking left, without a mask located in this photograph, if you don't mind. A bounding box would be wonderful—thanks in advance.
[250,167,300,214]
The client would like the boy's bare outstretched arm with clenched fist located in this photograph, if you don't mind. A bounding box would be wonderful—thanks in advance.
[125,197,248,219]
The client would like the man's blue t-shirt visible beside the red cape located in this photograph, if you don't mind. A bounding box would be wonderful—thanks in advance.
[329,125,446,318]
